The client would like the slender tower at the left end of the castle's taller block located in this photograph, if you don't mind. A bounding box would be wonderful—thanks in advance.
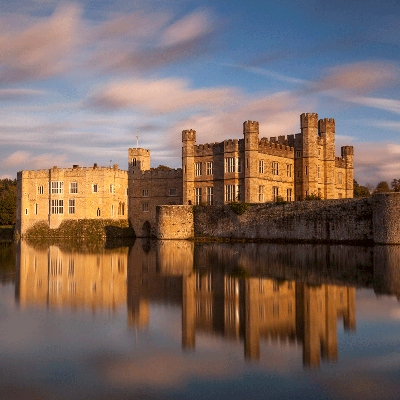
[182,129,196,205]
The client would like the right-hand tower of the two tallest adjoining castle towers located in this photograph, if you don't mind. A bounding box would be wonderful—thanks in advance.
[318,118,336,199]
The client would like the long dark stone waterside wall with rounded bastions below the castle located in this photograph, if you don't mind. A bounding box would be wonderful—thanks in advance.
[158,193,400,244]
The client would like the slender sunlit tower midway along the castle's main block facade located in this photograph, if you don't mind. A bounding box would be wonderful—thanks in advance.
[243,121,259,203]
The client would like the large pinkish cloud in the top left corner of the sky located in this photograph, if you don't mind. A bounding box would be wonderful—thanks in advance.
[0,5,80,82]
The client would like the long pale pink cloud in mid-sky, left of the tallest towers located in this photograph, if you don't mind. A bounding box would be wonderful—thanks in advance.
[88,78,236,113]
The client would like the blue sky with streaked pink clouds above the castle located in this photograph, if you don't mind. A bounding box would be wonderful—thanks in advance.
[0,0,400,185]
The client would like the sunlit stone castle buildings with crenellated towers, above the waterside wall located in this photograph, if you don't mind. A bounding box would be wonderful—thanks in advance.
[17,113,354,237]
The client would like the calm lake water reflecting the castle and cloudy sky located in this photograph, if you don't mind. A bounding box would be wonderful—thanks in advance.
[0,240,400,399]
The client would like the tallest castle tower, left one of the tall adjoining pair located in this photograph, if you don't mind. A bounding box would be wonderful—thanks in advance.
[294,113,318,200]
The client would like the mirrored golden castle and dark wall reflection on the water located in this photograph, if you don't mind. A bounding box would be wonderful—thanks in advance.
[16,240,400,366]
